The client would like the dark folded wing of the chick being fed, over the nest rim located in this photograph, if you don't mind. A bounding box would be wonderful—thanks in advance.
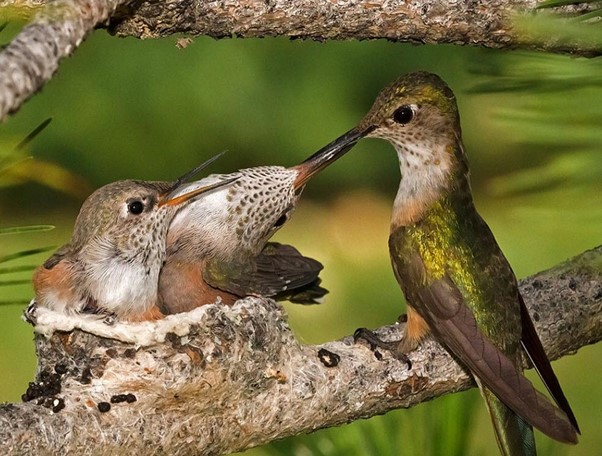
[204,242,327,303]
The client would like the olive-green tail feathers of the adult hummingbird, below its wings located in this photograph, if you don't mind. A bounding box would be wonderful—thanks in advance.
[478,382,537,456]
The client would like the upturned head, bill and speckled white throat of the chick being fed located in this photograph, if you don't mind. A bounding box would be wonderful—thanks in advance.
[167,131,362,261]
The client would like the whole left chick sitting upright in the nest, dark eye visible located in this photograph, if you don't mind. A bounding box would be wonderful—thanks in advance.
[33,157,233,321]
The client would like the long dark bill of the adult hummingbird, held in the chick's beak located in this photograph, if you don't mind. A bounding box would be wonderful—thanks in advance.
[292,128,369,190]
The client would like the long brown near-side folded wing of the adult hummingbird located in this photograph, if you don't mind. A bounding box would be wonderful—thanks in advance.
[416,276,577,443]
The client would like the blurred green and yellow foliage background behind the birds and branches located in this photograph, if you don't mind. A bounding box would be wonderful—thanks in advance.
[0,19,602,455]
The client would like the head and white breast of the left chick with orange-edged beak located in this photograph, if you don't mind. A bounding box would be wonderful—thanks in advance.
[66,175,231,316]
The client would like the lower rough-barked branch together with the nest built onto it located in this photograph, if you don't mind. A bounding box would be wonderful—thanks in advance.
[0,246,602,455]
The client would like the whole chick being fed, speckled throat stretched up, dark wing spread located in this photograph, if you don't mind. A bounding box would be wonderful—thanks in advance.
[159,128,359,314]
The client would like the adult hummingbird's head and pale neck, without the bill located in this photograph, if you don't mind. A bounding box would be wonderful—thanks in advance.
[356,72,468,224]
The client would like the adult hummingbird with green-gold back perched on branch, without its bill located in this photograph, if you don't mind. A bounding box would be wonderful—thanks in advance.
[336,72,579,456]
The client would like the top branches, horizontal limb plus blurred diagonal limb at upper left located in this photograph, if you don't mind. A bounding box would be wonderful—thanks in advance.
[0,0,600,121]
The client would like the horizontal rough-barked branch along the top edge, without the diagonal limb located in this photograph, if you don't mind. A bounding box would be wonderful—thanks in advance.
[110,0,592,56]
